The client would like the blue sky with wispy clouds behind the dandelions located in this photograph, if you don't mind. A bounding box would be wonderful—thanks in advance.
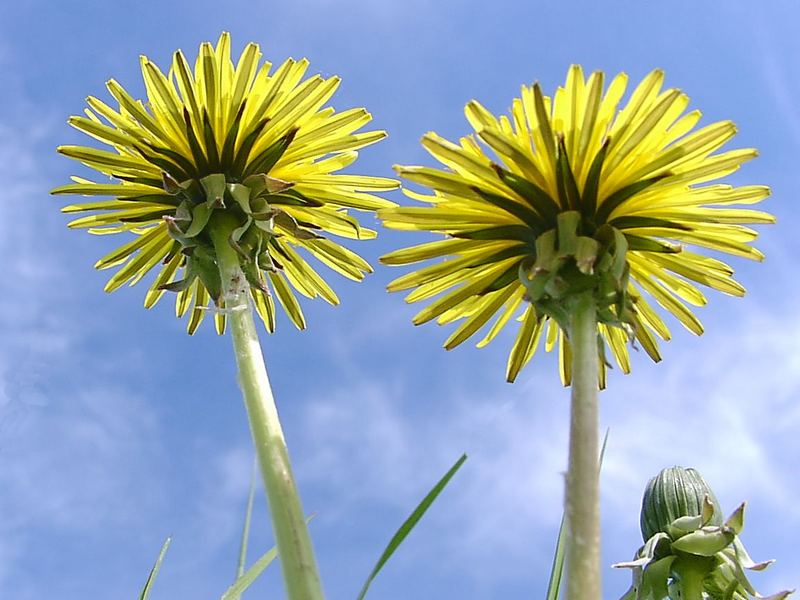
[0,0,800,600]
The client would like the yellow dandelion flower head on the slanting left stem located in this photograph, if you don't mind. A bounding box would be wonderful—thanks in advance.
[53,33,397,333]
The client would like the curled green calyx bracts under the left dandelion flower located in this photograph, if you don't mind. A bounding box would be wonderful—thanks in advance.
[156,168,321,306]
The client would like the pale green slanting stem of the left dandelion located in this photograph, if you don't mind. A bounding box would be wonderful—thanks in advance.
[209,214,324,600]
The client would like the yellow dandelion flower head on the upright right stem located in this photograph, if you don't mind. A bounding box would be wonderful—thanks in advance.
[379,66,774,386]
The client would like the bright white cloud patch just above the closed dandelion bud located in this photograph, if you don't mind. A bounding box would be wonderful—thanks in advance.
[605,304,800,516]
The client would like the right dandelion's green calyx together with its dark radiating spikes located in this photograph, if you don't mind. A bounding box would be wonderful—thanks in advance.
[504,134,685,364]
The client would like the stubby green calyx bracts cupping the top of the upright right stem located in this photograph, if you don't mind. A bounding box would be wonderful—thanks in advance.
[519,210,635,332]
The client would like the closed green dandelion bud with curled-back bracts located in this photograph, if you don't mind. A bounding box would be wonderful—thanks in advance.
[614,467,791,600]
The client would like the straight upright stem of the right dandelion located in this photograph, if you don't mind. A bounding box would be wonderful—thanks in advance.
[566,291,600,600]
